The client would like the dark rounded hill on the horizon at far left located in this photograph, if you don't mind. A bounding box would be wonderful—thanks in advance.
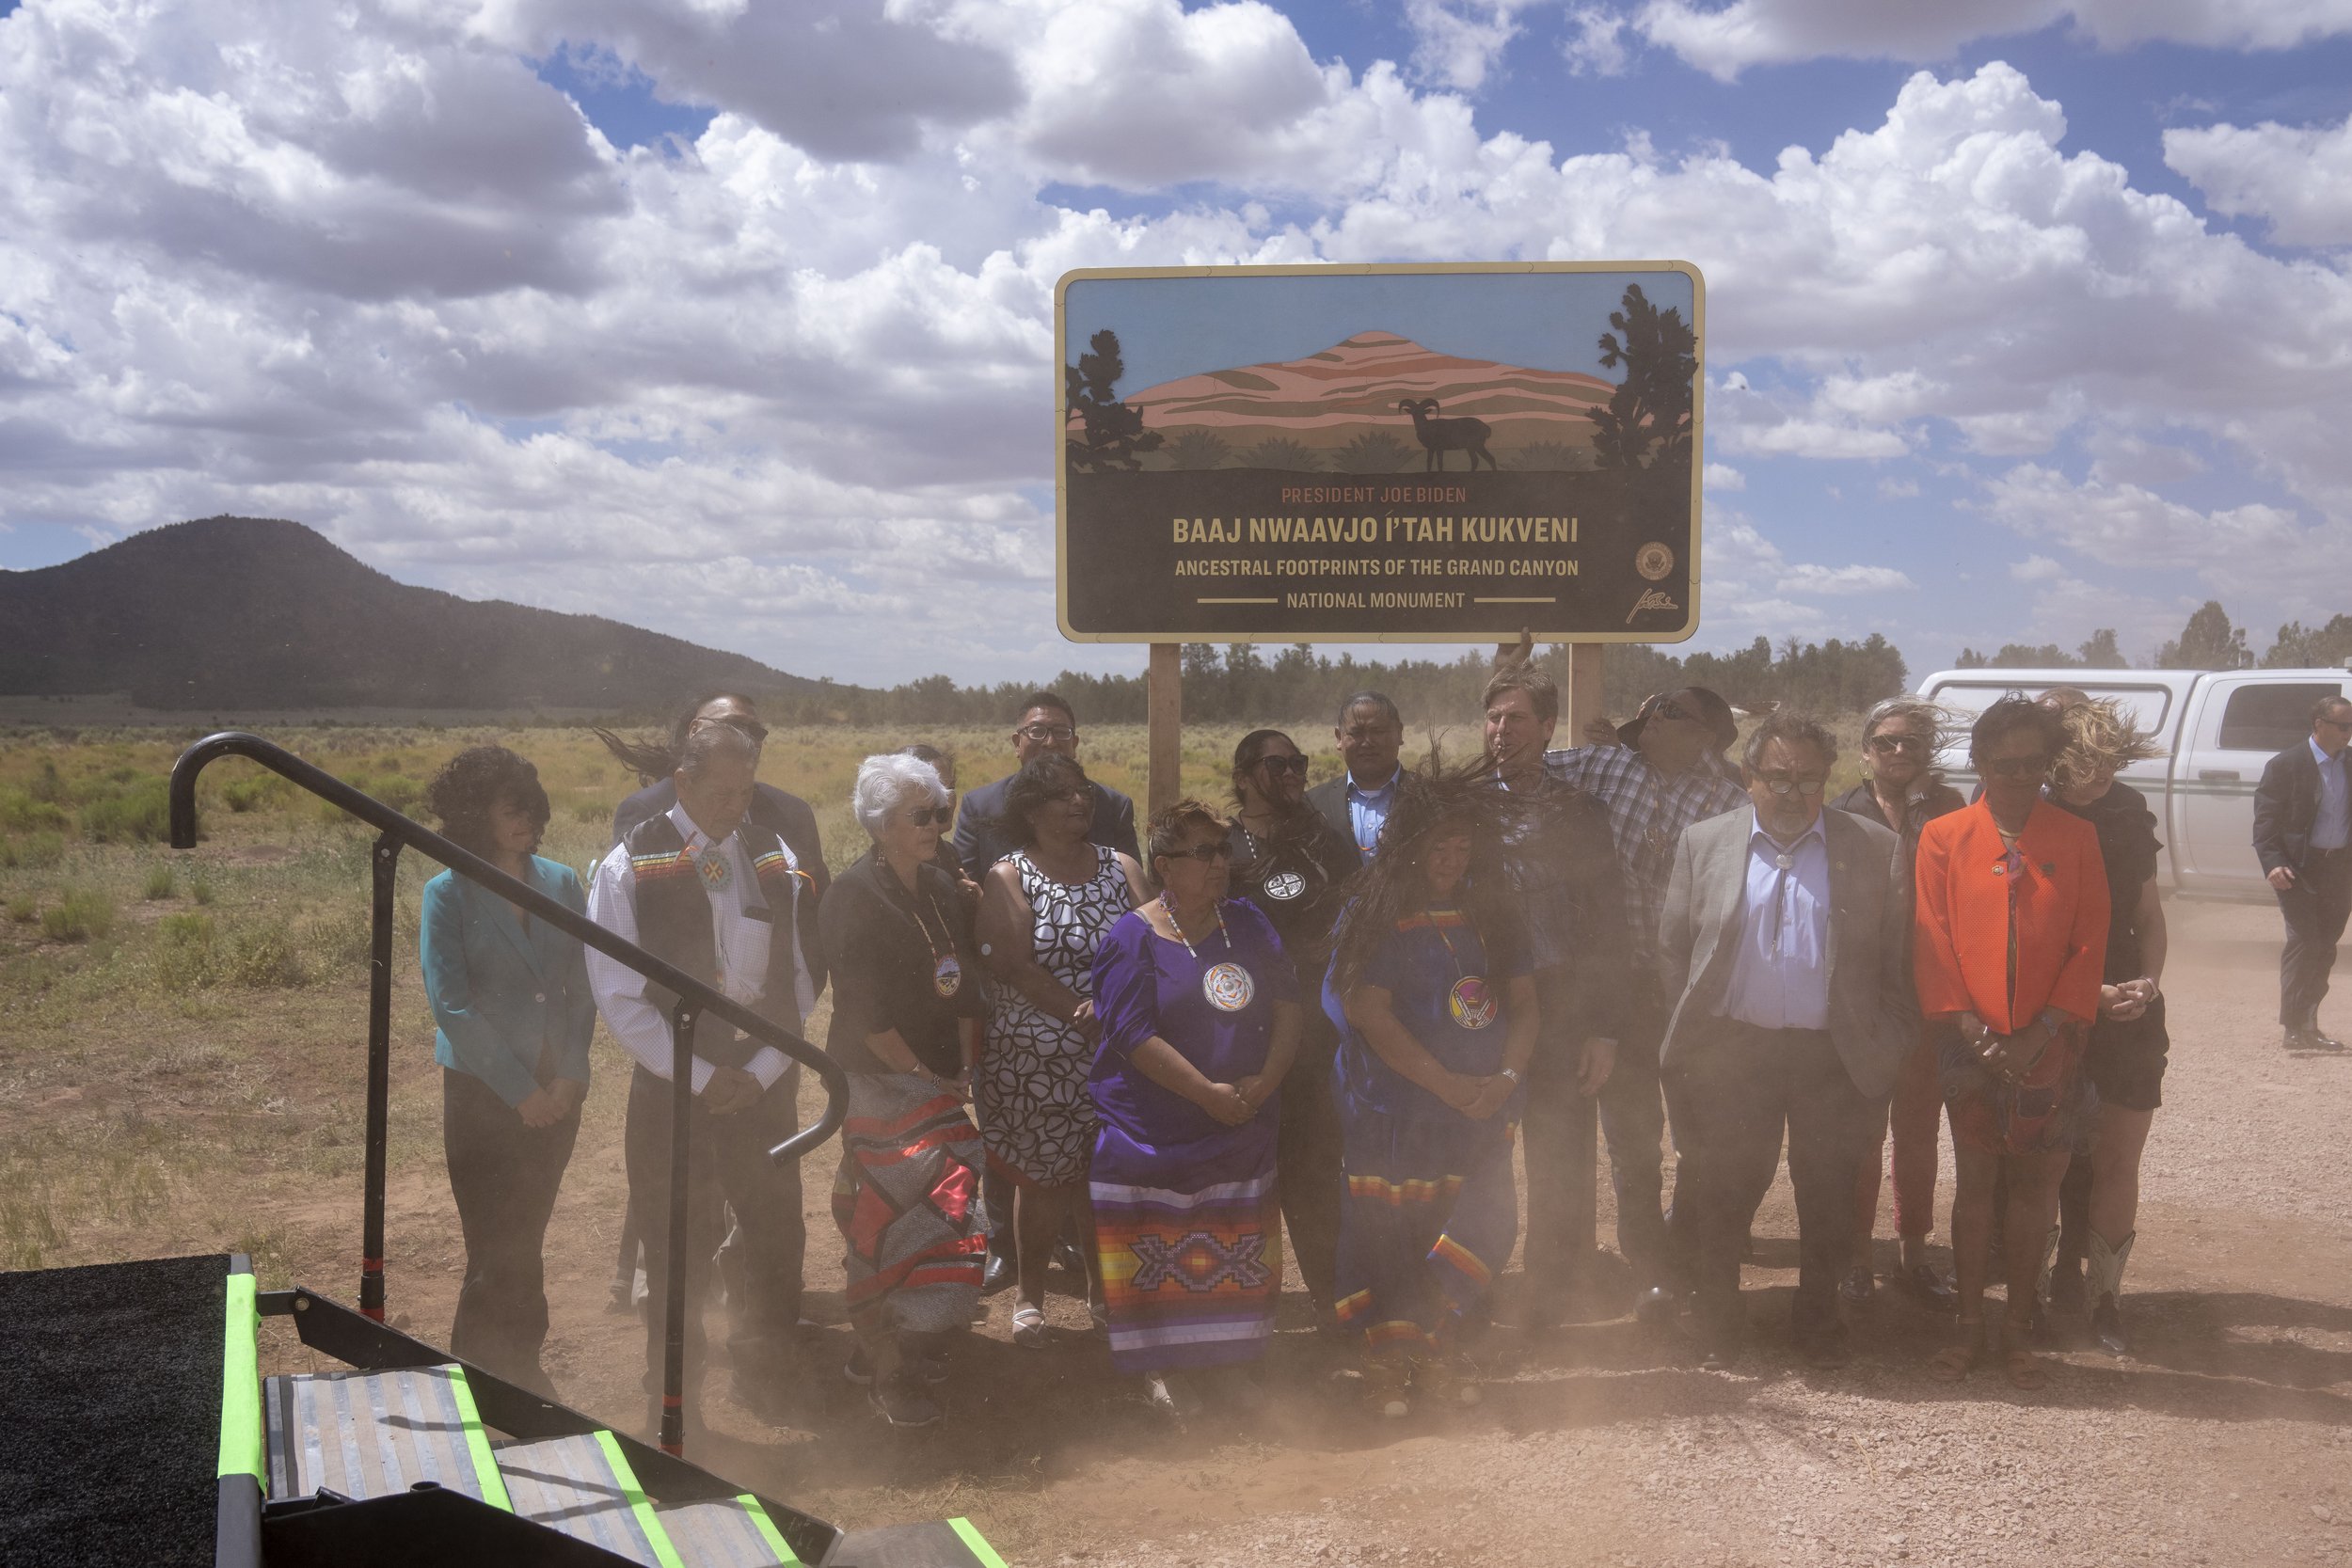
[0,517,833,712]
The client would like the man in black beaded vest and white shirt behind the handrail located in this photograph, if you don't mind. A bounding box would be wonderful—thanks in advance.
[588,724,817,1416]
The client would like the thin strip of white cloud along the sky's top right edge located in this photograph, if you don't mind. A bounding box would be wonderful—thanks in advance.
[1628,0,2352,82]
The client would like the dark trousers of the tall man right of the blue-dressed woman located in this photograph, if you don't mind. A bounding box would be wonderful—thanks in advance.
[1519,969,1599,1323]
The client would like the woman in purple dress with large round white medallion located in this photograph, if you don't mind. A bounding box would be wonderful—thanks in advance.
[1089,800,1301,1416]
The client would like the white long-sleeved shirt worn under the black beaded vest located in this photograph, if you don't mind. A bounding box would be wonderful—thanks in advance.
[588,806,817,1093]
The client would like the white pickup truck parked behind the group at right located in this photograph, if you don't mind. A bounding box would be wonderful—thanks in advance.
[1919,670,2352,903]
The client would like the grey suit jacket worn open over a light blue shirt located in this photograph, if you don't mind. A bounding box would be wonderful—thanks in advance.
[1659,806,1919,1098]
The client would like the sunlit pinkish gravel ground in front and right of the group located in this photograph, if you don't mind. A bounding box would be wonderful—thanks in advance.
[1044,903,2352,1568]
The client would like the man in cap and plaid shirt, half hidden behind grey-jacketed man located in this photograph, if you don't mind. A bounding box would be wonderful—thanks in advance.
[1543,687,1748,1322]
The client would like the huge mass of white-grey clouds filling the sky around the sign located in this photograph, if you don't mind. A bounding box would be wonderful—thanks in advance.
[0,0,2352,679]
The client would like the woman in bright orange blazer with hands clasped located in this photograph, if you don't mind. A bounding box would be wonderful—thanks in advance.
[1913,693,2107,1389]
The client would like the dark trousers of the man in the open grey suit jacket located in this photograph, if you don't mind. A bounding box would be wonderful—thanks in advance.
[1675,1018,1886,1338]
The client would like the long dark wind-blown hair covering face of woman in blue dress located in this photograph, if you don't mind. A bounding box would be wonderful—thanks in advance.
[1331,750,1546,997]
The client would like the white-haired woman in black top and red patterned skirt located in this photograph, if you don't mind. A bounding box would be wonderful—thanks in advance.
[821,752,988,1427]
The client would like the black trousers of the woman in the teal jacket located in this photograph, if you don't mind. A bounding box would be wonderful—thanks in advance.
[442,1068,581,1387]
